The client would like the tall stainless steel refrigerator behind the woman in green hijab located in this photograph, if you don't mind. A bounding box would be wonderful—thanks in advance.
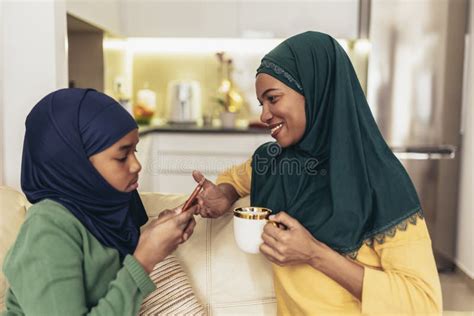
[365,0,469,270]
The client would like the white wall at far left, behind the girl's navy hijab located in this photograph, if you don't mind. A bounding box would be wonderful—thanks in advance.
[0,0,67,189]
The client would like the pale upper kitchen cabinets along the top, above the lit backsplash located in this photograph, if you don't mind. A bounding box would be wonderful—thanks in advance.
[122,0,359,38]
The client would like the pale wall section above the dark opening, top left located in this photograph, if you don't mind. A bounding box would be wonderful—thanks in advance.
[66,0,122,35]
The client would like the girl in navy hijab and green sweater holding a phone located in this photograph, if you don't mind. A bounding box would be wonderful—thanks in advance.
[3,89,195,315]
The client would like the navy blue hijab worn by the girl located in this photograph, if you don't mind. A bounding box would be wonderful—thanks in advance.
[21,89,148,258]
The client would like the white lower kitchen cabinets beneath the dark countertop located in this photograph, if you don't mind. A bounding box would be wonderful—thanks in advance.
[137,132,272,193]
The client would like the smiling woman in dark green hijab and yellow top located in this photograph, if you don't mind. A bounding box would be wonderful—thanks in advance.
[193,32,442,315]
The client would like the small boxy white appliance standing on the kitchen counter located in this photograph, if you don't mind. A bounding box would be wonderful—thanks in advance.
[167,80,201,124]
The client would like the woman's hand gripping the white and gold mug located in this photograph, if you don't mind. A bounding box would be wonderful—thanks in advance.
[260,212,325,266]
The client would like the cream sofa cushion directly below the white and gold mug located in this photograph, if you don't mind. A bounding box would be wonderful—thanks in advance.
[209,197,276,315]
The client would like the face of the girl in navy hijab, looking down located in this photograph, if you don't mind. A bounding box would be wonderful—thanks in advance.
[89,129,142,192]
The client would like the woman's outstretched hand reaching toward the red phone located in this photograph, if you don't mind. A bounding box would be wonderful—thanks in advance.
[193,171,234,218]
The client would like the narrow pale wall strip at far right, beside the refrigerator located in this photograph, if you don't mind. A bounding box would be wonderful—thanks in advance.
[456,1,474,278]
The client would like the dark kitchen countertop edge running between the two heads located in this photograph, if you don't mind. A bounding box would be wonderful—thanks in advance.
[139,124,269,136]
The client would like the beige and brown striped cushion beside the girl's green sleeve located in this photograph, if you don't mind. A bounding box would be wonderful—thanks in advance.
[140,256,205,316]
